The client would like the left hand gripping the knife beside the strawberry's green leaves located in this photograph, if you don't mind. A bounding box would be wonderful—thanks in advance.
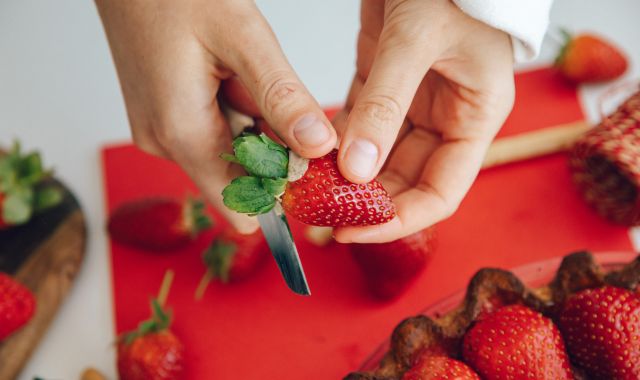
[96,0,336,233]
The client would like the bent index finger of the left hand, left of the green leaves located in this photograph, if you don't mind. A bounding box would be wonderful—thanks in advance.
[152,49,258,233]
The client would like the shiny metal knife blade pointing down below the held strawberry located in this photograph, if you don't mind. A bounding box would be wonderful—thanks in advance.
[258,204,311,296]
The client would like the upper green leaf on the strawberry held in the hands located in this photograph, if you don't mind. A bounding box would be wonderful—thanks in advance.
[227,133,289,178]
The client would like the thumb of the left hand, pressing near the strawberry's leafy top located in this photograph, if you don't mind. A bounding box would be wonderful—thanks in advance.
[227,10,336,158]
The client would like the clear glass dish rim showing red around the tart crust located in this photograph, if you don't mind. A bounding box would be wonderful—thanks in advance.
[359,252,638,371]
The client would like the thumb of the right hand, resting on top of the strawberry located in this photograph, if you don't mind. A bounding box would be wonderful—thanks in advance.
[338,18,437,183]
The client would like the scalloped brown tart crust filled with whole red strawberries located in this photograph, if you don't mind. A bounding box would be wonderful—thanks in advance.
[345,252,640,380]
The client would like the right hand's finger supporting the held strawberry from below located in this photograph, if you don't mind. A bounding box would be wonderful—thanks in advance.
[335,140,488,243]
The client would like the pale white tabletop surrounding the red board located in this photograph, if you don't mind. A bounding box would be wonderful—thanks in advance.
[0,0,640,380]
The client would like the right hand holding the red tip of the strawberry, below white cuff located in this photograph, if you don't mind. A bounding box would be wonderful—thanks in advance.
[334,0,514,243]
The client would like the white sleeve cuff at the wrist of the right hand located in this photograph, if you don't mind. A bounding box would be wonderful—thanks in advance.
[453,0,553,62]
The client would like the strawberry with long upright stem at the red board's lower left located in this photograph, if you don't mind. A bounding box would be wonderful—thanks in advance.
[117,271,184,380]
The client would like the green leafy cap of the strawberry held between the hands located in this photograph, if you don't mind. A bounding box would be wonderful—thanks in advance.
[221,133,289,216]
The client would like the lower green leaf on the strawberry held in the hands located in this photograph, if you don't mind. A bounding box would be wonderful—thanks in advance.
[222,176,276,215]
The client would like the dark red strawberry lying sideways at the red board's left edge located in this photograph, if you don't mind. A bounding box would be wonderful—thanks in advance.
[108,198,211,251]
